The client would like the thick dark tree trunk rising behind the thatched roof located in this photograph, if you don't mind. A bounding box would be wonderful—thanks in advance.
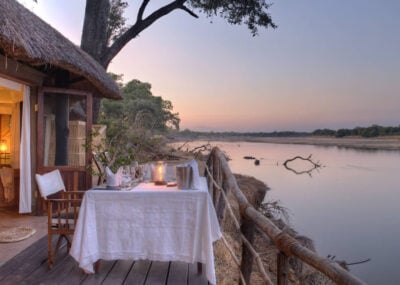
[81,0,110,123]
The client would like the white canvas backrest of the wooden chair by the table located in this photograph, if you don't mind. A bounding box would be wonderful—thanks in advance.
[35,169,65,200]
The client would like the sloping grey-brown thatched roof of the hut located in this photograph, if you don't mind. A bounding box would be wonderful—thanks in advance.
[0,0,121,99]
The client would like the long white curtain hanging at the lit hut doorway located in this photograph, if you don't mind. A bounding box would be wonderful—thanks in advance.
[19,86,32,214]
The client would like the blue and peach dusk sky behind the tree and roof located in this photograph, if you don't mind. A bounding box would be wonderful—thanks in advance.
[20,0,400,132]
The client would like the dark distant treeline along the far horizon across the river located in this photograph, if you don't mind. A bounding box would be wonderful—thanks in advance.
[179,125,400,138]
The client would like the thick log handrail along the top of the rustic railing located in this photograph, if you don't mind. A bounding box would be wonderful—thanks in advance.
[209,147,366,285]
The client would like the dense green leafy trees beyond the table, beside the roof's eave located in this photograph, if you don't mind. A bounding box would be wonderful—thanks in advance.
[94,77,180,170]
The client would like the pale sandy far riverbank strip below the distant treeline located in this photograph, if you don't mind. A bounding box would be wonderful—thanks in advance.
[170,136,400,151]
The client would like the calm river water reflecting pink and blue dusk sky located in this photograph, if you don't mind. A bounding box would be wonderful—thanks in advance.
[188,142,400,285]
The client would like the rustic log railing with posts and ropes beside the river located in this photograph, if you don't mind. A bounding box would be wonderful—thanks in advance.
[206,147,366,285]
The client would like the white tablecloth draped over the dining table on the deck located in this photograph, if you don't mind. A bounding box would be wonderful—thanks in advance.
[70,178,221,284]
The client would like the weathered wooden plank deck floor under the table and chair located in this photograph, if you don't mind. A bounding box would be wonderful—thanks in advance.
[0,236,209,285]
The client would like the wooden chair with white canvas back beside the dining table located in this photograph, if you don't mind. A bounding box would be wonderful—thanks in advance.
[35,169,85,268]
